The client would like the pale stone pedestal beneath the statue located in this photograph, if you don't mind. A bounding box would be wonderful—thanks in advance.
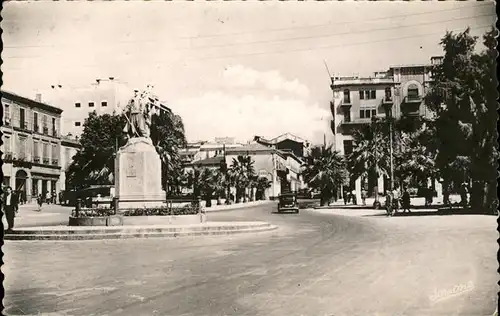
[115,137,166,210]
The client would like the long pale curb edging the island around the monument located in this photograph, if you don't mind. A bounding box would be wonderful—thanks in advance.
[4,222,278,240]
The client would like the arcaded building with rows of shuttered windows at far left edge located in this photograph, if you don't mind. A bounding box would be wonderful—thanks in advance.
[1,90,62,202]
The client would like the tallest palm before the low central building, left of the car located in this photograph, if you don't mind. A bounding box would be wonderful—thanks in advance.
[228,156,255,203]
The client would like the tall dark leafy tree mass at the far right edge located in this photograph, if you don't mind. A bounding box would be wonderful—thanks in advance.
[426,29,499,212]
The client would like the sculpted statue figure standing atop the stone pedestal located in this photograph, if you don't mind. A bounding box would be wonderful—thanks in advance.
[123,87,156,138]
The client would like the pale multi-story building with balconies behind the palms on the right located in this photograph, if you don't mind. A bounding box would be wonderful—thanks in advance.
[330,57,442,200]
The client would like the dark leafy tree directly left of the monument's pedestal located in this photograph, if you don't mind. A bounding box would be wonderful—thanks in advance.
[67,111,124,189]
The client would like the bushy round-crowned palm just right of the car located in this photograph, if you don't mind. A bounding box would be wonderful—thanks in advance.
[303,146,348,206]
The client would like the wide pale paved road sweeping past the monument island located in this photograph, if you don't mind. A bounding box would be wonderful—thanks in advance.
[3,205,498,316]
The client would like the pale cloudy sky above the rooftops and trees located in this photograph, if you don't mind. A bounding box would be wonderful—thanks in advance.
[1,1,496,143]
